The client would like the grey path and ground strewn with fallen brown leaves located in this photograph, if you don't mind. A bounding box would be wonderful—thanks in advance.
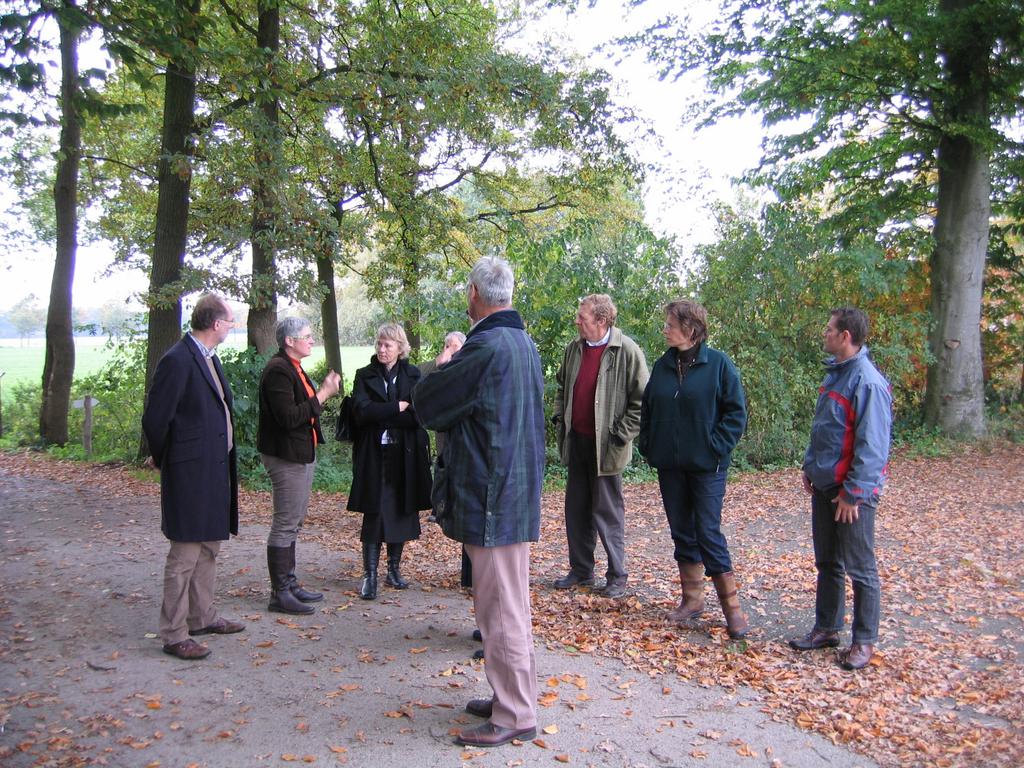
[0,444,1024,766]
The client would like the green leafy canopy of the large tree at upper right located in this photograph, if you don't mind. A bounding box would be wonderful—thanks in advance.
[629,0,1024,233]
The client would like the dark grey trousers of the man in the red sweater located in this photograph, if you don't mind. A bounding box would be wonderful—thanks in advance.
[565,431,627,582]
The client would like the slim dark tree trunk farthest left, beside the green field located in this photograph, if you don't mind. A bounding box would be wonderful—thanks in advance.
[39,0,82,445]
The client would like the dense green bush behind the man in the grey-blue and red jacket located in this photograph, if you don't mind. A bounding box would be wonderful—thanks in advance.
[693,205,927,469]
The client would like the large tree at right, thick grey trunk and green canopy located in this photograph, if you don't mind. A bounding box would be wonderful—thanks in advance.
[631,0,1024,436]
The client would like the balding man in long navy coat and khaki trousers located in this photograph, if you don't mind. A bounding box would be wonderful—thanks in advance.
[142,294,245,659]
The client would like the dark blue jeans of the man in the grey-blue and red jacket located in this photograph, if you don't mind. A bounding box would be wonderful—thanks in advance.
[811,487,882,645]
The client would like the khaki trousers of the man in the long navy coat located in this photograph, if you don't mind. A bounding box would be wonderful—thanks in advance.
[160,542,220,645]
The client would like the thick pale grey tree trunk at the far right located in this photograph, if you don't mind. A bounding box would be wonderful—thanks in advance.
[925,0,991,437]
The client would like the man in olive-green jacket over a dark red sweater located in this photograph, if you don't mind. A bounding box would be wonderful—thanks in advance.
[553,294,647,598]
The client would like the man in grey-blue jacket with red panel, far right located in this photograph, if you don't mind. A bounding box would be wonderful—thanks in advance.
[790,307,892,670]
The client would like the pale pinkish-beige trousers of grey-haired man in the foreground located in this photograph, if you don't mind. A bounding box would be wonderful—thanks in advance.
[466,542,537,730]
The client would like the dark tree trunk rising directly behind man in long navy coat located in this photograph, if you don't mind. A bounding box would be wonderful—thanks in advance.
[139,0,200,456]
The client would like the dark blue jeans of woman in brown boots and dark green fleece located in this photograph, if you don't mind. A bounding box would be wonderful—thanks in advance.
[657,469,732,577]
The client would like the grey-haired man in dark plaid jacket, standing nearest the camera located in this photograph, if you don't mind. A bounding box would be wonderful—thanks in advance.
[413,256,544,746]
